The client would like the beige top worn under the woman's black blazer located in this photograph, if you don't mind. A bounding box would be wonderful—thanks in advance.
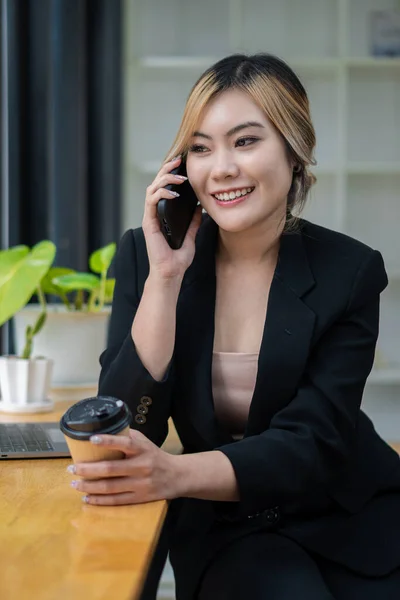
[212,352,258,439]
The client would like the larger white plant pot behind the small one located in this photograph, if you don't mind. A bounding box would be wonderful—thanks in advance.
[14,304,111,386]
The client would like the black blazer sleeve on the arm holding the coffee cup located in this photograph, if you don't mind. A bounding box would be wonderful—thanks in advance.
[215,251,388,518]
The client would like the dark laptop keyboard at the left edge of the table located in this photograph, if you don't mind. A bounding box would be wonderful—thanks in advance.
[0,423,54,453]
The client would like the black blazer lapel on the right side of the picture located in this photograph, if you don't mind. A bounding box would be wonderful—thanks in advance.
[245,230,316,436]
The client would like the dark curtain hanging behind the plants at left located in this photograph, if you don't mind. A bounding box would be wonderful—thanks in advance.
[0,0,122,351]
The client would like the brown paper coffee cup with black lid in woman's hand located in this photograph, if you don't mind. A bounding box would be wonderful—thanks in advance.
[60,396,132,472]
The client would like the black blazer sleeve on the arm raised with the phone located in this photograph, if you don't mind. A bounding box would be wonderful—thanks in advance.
[98,230,174,446]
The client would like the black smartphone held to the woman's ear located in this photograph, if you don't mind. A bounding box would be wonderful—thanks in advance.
[157,162,198,250]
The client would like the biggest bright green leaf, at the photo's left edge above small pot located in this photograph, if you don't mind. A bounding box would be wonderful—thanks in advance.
[0,240,56,325]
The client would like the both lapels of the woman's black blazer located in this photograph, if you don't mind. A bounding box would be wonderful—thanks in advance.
[176,216,315,448]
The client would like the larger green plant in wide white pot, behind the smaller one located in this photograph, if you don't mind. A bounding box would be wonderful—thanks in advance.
[14,243,116,400]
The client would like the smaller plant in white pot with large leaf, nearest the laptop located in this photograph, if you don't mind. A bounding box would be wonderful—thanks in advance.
[0,240,56,412]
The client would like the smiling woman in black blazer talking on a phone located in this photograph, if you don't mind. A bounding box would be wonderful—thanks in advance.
[69,54,400,600]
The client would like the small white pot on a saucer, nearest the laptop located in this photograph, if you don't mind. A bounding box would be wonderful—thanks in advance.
[0,356,53,412]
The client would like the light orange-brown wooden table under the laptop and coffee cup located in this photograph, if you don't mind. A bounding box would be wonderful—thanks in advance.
[0,402,167,600]
